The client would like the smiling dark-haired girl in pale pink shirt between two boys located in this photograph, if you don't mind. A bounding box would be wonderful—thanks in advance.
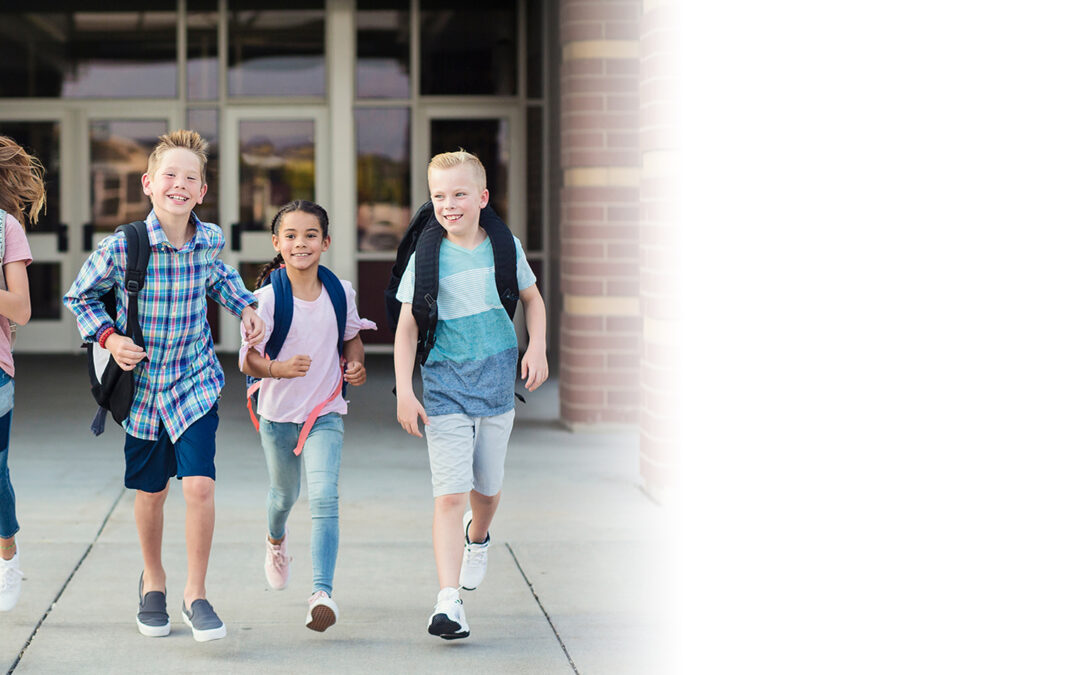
[240,200,375,631]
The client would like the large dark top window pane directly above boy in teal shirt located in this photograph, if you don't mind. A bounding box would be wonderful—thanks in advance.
[420,0,517,95]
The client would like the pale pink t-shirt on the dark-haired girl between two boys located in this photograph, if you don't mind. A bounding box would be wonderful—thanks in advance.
[240,279,370,424]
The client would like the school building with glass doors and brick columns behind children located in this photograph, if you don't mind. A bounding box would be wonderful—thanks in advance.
[0,0,679,496]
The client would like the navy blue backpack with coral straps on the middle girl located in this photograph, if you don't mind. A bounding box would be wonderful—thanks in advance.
[247,265,347,455]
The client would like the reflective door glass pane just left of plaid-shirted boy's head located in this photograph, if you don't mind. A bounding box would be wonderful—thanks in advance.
[90,120,167,231]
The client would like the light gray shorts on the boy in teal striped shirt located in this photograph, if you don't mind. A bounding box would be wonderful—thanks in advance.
[424,409,514,497]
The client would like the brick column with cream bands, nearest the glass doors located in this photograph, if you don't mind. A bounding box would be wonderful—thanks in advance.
[559,0,642,428]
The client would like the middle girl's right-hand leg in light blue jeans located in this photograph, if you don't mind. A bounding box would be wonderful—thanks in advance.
[303,413,345,595]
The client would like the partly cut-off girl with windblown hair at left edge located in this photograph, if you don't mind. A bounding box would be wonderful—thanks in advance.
[0,136,45,611]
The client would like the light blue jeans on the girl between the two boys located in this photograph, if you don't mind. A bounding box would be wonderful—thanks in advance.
[259,413,345,595]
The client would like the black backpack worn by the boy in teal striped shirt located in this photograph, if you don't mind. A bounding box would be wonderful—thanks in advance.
[386,200,518,364]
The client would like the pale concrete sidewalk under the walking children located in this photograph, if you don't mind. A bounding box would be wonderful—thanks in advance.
[0,354,666,674]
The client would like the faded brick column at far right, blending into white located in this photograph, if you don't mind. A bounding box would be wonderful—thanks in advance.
[639,0,686,498]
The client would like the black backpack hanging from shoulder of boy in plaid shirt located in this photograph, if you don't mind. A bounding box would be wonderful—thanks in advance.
[83,220,150,436]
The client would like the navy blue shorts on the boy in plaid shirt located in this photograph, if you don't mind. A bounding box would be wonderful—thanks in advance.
[124,403,217,492]
